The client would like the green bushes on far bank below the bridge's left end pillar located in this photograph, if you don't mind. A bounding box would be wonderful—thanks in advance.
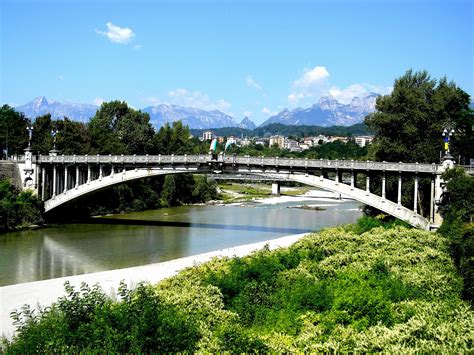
[0,179,42,228]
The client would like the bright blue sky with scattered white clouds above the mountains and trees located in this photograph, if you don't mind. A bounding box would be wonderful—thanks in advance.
[0,0,474,123]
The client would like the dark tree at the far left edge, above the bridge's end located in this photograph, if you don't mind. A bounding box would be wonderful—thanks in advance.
[0,105,28,155]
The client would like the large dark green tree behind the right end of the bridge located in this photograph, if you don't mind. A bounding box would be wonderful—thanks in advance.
[365,70,474,163]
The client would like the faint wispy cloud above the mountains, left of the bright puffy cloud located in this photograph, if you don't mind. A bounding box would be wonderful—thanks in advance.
[168,89,231,114]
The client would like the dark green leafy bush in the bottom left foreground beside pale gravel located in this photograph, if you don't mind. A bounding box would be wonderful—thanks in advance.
[7,282,200,353]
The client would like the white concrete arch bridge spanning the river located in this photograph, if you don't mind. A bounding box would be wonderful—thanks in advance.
[19,151,462,229]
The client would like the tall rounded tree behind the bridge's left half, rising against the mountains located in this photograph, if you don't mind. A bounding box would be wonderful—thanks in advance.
[89,101,154,154]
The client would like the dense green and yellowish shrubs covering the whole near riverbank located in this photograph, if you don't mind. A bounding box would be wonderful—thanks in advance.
[4,217,474,353]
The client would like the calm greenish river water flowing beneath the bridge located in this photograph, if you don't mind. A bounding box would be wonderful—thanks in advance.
[0,198,361,286]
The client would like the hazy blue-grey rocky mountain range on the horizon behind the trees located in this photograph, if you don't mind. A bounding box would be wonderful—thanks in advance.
[15,93,378,130]
